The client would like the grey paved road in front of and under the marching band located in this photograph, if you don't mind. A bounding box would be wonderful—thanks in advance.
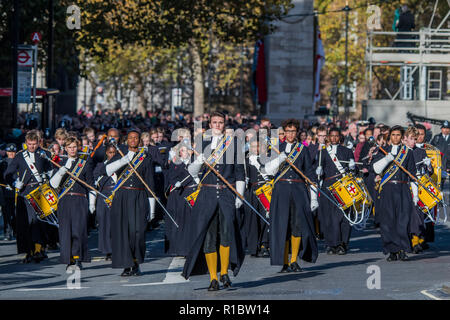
[0,215,450,300]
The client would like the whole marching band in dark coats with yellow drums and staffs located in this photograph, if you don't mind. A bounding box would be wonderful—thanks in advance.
[0,112,450,291]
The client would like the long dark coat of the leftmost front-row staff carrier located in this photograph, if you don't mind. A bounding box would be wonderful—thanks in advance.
[55,157,94,264]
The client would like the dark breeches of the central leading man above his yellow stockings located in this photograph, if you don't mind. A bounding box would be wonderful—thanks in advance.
[203,206,233,253]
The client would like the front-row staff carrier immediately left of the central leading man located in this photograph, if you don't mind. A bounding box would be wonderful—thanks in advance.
[100,129,155,277]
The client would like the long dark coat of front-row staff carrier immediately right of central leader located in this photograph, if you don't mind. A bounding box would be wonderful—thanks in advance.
[270,142,318,265]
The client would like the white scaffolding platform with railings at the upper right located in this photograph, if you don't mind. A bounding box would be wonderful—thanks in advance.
[365,28,450,101]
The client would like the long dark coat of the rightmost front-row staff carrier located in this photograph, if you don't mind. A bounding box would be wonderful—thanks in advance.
[371,146,416,254]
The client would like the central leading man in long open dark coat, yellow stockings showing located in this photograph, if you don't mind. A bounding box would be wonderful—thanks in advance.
[183,112,245,291]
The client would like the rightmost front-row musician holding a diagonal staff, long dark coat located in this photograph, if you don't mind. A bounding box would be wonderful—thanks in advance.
[371,126,419,261]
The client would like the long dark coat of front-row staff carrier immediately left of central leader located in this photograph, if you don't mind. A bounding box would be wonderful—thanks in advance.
[99,149,154,268]
